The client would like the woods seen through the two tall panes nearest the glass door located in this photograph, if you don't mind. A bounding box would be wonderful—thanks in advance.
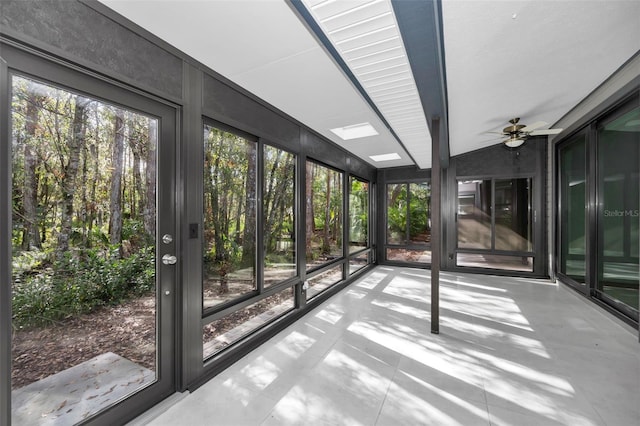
[203,125,296,307]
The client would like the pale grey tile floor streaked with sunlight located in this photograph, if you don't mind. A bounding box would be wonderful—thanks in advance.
[133,266,640,426]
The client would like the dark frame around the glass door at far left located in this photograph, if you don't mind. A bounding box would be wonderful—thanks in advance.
[0,40,181,424]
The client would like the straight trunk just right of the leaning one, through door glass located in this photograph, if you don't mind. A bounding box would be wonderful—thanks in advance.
[109,110,124,254]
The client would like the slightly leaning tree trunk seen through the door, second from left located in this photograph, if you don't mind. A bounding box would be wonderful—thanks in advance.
[56,96,89,259]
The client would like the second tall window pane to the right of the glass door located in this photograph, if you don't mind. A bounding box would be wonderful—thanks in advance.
[262,145,296,287]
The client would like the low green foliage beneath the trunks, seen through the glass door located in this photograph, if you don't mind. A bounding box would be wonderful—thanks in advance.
[12,247,155,327]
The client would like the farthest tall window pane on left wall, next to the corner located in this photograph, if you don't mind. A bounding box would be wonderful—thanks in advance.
[349,177,369,253]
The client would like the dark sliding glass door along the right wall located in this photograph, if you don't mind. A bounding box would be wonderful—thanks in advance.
[557,96,640,321]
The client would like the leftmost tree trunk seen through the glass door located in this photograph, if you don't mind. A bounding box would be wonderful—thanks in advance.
[22,88,42,250]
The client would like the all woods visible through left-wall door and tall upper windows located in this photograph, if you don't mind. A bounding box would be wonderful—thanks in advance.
[12,77,376,318]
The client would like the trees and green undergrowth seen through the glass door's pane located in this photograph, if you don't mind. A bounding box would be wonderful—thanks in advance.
[12,76,157,326]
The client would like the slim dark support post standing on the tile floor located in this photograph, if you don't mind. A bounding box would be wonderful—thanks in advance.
[431,117,442,334]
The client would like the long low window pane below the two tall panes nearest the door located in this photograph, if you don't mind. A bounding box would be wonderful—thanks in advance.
[202,287,294,359]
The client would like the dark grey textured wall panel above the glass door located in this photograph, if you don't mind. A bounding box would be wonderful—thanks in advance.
[0,0,182,98]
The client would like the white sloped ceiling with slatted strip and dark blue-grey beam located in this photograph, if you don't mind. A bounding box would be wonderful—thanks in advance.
[100,0,640,168]
